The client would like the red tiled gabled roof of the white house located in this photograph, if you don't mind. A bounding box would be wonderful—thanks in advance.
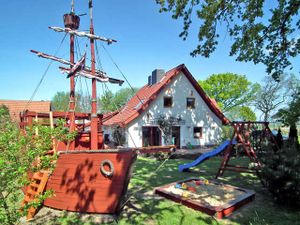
[104,64,229,127]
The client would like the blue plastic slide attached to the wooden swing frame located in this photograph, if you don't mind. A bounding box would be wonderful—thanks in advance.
[178,140,235,172]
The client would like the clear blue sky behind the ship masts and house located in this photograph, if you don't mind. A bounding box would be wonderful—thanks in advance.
[0,0,299,100]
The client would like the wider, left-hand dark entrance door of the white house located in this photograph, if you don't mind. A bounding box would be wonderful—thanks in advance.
[142,127,161,147]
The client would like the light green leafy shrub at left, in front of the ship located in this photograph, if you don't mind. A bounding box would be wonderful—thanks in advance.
[0,106,75,225]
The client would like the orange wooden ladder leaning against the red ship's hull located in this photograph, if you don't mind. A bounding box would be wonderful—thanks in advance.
[22,170,50,220]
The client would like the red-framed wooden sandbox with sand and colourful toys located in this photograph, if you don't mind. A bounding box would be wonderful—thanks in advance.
[155,178,255,219]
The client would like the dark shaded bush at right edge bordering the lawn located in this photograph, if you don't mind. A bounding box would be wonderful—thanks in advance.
[260,144,300,209]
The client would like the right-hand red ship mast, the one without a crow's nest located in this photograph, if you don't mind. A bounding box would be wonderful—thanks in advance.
[89,0,98,150]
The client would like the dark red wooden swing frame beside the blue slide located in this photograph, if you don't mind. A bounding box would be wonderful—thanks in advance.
[216,121,278,178]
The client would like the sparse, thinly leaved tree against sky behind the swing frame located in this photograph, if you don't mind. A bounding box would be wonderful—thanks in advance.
[254,76,289,121]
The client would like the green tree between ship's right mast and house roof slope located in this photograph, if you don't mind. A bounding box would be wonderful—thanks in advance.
[100,88,138,112]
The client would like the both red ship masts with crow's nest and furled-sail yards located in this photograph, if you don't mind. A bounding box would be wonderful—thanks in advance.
[31,0,124,150]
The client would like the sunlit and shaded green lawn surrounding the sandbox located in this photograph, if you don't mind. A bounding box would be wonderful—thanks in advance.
[28,157,300,225]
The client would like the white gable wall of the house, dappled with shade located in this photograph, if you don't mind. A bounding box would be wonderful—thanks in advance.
[126,73,222,147]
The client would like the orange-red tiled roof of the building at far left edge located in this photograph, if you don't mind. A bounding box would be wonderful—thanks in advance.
[0,100,51,122]
